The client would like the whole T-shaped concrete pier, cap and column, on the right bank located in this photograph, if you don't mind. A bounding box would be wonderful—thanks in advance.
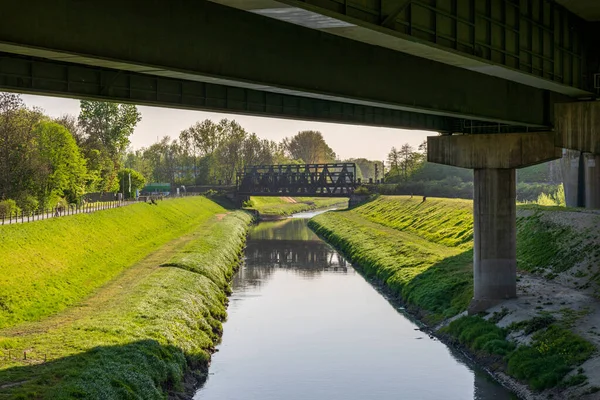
[427,133,561,314]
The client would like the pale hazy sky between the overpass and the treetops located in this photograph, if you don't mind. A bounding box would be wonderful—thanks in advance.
[22,95,436,160]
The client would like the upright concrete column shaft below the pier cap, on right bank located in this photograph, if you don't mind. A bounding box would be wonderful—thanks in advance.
[469,168,517,312]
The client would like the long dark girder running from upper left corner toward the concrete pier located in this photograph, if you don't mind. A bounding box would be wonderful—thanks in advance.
[0,0,570,127]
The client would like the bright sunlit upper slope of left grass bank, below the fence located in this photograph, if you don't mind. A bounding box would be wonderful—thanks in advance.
[0,197,223,329]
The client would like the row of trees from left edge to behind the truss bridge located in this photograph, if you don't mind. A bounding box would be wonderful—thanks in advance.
[0,93,383,212]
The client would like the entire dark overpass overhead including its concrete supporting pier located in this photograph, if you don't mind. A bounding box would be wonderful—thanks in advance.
[0,0,600,311]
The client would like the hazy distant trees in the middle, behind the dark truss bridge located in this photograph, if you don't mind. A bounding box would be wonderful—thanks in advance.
[124,119,335,185]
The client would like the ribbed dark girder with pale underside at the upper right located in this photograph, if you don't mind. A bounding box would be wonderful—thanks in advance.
[211,0,600,97]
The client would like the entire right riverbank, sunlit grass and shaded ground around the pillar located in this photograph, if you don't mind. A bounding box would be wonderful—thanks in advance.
[309,196,600,400]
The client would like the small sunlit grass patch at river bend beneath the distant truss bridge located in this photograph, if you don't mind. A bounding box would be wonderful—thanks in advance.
[247,196,348,217]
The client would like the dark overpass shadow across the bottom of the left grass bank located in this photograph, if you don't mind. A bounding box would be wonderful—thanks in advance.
[0,340,203,399]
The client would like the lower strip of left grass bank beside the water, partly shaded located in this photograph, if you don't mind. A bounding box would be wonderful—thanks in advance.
[0,205,251,399]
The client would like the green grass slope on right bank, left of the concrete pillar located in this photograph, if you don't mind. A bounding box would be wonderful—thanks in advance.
[309,196,473,322]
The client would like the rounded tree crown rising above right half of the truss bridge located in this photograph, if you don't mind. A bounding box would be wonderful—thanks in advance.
[283,131,336,164]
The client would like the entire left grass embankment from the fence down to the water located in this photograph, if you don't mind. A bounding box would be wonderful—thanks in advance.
[0,198,250,399]
